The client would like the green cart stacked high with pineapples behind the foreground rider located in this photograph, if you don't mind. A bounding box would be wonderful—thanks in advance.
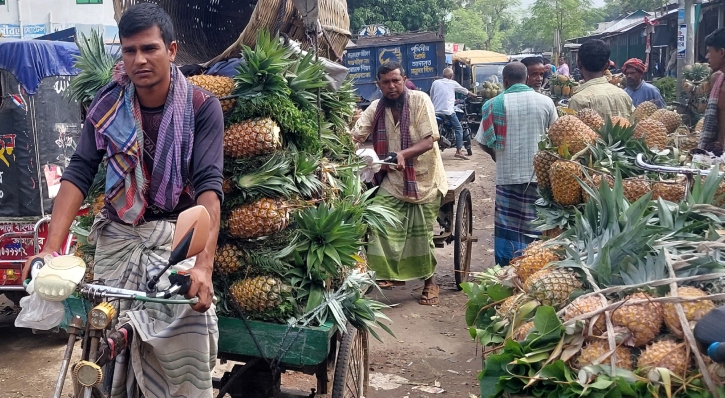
[68,31,399,397]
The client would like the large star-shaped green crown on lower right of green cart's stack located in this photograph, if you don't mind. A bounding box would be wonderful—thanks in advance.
[295,203,365,280]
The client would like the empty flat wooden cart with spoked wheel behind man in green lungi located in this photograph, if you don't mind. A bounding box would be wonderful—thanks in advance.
[433,170,478,290]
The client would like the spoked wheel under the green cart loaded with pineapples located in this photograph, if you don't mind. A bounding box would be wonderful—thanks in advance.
[332,324,368,398]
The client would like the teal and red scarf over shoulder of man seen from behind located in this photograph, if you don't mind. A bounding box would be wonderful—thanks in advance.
[476,83,534,151]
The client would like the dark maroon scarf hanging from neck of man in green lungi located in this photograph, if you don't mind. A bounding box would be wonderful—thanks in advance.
[372,89,420,199]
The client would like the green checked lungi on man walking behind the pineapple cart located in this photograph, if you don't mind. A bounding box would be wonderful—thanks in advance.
[367,188,441,281]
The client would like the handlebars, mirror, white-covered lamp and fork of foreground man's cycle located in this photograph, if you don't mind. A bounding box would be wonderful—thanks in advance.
[24,206,211,398]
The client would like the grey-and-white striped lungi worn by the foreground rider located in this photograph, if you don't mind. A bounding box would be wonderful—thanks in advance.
[89,215,219,398]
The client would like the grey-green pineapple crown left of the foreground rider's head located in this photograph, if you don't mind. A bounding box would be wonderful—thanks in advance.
[65,30,120,105]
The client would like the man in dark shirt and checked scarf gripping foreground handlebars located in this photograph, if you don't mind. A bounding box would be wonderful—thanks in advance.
[23,3,224,398]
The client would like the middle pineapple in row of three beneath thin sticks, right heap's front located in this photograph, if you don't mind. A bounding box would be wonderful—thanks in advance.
[612,293,664,347]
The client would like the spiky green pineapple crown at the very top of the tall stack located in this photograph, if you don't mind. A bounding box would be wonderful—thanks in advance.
[234,29,292,97]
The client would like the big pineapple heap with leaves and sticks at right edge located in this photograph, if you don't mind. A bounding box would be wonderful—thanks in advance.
[464,103,725,397]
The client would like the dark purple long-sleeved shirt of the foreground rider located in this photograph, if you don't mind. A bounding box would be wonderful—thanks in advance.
[61,87,224,223]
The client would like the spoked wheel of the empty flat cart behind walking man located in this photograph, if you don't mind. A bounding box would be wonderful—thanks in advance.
[453,189,473,290]
